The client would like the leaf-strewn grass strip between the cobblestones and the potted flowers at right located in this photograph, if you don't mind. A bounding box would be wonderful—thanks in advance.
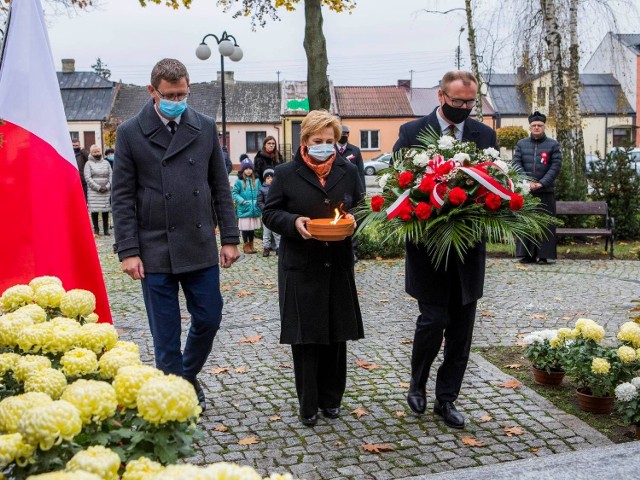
[473,346,636,443]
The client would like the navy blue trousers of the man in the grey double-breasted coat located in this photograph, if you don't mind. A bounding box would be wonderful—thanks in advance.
[142,265,222,378]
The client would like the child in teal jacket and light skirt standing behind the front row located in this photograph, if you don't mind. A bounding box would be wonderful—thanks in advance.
[233,157,262,253]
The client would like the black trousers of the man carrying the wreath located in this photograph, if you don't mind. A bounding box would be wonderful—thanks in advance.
[411,295,477,402]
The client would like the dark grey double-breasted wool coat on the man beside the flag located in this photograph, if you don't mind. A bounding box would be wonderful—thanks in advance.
[113,100,239,274]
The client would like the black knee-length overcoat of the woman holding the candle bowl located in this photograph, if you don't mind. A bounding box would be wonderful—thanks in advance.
[262,153,364,345]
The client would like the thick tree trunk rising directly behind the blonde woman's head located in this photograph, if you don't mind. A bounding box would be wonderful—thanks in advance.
[304,0,331,110]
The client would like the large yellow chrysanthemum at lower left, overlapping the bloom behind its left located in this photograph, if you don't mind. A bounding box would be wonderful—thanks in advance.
[18,400,82,450]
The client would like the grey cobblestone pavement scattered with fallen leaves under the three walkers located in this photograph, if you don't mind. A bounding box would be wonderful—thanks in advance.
[98,237,640,480]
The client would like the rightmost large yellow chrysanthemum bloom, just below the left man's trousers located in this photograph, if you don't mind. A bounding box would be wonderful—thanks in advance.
[137,375,202,425]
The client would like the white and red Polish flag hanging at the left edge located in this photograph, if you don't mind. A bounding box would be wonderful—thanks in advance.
[0,0,111,322]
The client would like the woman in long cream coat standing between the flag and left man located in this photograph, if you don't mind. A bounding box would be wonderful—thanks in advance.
[84,145,111,236]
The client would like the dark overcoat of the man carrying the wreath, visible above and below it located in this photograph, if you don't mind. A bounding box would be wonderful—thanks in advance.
[393,108,498,305]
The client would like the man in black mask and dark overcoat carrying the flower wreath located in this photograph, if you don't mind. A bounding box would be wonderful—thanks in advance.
[393,71,497,428]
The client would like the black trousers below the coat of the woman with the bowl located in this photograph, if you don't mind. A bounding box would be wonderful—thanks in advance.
[291,342,347,417]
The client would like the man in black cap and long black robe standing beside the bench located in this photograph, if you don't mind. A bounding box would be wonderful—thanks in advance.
[513,111,562,264]
